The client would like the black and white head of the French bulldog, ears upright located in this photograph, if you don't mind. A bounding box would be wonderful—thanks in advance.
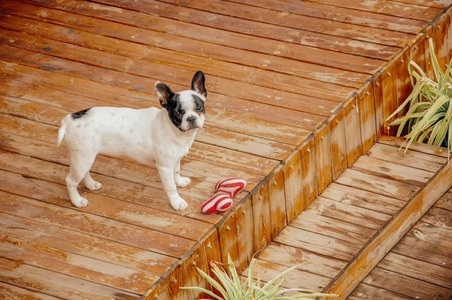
[155,71,207,131]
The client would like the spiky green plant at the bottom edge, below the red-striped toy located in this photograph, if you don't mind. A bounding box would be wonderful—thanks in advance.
[182,255,335,300]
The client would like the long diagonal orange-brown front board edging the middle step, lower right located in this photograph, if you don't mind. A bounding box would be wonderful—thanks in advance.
[325,161,452,298]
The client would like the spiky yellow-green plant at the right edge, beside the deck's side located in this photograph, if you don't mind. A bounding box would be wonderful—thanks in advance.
[388,39,452,162]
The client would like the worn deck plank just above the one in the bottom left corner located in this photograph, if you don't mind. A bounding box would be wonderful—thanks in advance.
[0,257,139,299]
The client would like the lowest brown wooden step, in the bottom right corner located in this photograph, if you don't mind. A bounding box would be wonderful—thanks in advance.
[348,188,452,300]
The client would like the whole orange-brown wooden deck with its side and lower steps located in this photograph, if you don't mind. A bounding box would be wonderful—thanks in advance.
[0,0,452,299]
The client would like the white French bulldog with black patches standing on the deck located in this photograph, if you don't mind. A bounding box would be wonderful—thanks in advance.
[58,71,207,210]
